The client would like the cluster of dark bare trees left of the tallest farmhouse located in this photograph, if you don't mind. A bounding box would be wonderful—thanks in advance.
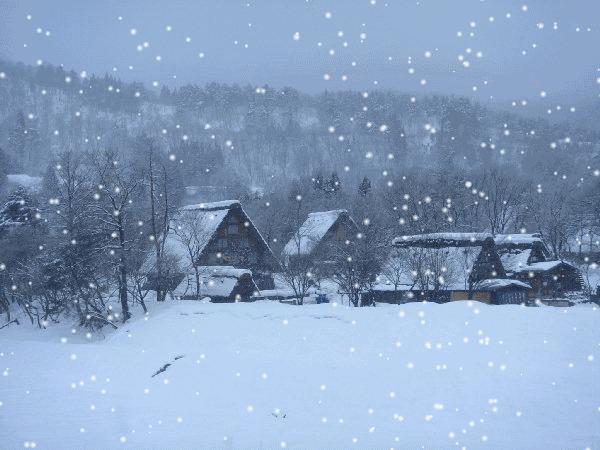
[0,138,182,328]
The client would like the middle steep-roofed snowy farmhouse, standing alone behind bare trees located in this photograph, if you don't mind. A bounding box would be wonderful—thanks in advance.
[282,209,358,268]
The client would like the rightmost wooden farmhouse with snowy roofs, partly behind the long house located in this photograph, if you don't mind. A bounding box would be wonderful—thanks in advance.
[494,234,583,299]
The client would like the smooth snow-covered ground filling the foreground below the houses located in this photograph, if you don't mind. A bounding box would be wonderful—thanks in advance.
[0,302,600,450]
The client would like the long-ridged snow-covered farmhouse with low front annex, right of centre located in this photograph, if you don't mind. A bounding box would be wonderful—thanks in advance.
[371,233,530,304]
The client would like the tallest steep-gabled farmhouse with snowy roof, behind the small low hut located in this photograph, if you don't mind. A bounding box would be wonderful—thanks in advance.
[144,200,279,289]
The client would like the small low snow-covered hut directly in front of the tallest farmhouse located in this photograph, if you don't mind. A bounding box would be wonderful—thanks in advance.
[173,266,258,303]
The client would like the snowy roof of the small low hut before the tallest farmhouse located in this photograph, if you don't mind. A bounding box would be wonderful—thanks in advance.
[173,266,258,297]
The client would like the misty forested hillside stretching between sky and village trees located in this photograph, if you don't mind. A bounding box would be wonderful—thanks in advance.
[0,57,600,192]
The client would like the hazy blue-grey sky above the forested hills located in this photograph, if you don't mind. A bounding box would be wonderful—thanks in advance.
[0,0,600,102]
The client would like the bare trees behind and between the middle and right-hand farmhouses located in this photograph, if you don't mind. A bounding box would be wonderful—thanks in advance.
[254,165,600,306]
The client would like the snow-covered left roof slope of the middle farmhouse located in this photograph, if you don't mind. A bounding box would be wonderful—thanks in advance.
[283,209,348,256]
